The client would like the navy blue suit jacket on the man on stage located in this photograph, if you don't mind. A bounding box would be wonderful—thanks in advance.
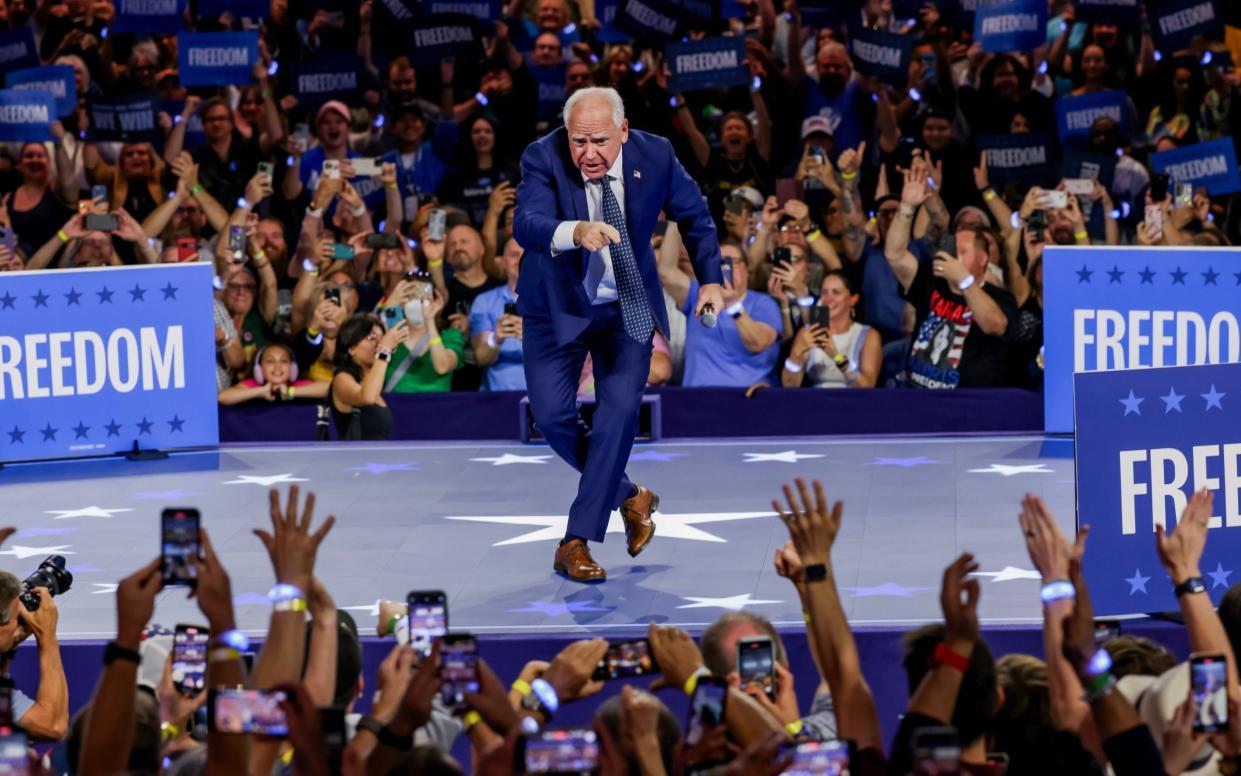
[513,127,722,345]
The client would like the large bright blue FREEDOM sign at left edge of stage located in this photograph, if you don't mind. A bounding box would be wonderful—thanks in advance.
[0,263,220,462]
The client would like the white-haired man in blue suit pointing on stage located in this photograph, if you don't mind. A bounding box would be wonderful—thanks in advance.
[513,88,724,582]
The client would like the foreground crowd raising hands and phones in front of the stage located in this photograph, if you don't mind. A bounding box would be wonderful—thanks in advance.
[0,479,1241,776]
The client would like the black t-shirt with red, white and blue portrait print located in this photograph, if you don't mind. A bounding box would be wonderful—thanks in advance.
[905,262,1018,389]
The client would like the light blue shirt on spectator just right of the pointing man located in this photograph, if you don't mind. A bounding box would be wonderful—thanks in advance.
[681,281,784,387]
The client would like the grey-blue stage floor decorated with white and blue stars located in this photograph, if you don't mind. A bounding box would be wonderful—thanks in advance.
[0,436,1075,639]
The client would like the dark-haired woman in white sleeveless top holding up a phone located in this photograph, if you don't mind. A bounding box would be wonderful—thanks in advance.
[781,269,884,387]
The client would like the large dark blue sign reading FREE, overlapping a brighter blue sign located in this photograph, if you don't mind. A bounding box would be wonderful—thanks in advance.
[1073,364,1241,617]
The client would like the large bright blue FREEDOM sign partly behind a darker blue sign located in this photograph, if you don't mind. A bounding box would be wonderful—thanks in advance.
[1042,246,1241,432]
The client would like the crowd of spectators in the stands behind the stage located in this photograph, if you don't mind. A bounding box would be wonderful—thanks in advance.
[0,0,1241,417]
